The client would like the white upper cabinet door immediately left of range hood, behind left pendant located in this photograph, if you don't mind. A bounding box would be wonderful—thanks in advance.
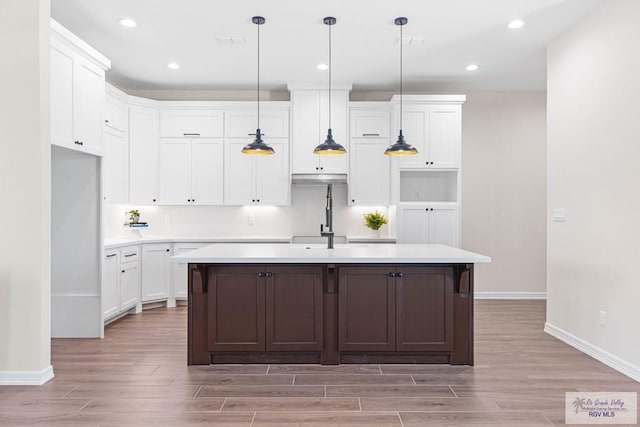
[253,139,291,205]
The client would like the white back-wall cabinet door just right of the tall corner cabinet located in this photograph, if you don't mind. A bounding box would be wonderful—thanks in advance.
[160,138,192,205]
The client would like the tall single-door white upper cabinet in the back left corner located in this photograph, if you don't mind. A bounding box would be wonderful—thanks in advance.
[129,105,160,205]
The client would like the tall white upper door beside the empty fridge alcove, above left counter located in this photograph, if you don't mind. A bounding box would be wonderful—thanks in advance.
[102,128,129,204]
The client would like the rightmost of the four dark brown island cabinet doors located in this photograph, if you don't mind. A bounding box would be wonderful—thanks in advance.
[396,265,454,351]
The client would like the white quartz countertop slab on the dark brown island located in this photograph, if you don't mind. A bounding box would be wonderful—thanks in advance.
[171,243,491,264]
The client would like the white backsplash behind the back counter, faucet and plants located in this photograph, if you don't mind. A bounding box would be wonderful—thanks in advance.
[104,184,393,238]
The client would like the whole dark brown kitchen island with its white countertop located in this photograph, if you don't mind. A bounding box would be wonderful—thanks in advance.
[173,244,491,365]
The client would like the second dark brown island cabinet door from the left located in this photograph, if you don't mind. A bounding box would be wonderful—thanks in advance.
[265,266,323,351]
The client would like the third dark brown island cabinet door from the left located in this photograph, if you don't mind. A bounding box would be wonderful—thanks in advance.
[338,266,396,352]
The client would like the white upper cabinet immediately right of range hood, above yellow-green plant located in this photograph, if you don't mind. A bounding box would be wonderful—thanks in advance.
[348,107,390,206]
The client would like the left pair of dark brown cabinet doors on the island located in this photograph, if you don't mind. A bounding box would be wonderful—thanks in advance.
[208,266,322,352]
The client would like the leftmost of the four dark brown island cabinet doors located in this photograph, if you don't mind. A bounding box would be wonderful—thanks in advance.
[208,266,265,351]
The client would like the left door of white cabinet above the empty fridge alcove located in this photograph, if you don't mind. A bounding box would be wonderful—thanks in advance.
[50,40,76,149]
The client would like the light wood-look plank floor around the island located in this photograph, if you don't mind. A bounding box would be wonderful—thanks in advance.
[0,301,640,427]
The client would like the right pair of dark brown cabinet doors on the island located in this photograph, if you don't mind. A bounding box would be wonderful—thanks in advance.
[338,266,454,352]
